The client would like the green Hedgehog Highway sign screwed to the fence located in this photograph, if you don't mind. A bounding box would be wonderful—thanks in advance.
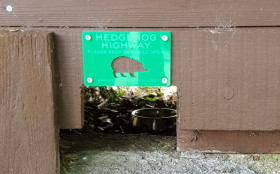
[82,31,171,86]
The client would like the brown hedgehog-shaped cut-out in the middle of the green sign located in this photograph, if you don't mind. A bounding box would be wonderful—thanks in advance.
[112,56,148,78]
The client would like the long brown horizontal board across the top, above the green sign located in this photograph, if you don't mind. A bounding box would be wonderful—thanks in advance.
[0,0,280,28]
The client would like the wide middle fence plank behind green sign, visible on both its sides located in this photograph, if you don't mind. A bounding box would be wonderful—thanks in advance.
[4,27,280,130]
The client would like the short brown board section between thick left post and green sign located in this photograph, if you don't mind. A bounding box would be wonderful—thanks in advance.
[51,29,84,129]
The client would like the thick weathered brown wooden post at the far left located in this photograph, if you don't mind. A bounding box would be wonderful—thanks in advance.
[0,30,58,174]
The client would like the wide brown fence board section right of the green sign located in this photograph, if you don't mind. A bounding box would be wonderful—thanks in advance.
[177,28,280,130]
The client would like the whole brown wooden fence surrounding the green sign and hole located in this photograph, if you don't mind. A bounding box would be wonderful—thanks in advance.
[0,0,280,173]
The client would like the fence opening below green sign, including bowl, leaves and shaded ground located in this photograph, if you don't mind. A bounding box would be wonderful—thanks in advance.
[60,86,177,173]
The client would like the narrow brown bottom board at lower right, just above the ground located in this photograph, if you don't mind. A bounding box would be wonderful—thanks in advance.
[177,129,280,153]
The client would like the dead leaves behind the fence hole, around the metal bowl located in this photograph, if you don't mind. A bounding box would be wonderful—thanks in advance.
[79,87,176,135]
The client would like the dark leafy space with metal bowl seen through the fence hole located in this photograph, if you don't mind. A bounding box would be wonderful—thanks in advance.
[72,86,177,135]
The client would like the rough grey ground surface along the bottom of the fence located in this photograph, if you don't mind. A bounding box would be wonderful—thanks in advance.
[60,133,280,174]
